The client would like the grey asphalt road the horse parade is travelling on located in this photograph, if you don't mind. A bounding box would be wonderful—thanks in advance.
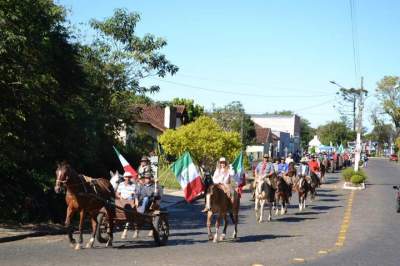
[0,160,390,266]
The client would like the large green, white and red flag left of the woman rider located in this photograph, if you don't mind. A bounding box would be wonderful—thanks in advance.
[171,152,204,202]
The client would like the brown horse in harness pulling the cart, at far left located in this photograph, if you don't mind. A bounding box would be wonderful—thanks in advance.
[54,162,115,250]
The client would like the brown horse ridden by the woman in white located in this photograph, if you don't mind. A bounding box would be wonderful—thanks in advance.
[207,184,240,243]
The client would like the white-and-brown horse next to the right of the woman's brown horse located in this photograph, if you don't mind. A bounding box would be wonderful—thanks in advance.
[254,176,276,223]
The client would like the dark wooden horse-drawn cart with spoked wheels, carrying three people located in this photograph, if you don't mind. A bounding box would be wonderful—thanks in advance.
[96,200,169,246]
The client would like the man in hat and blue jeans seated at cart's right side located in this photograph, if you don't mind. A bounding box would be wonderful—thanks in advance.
[136,171,160,213]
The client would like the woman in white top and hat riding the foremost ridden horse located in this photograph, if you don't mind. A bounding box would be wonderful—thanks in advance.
[202,157,234,212]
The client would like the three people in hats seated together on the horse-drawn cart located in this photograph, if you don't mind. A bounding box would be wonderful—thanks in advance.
[110,156,161,213]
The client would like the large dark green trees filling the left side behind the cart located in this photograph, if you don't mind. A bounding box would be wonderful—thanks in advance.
[0,0,178,220]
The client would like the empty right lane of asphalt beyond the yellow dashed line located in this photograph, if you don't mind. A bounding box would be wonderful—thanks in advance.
[310,159,400,266]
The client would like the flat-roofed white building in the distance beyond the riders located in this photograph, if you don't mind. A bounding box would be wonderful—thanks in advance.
[251,115,301,153]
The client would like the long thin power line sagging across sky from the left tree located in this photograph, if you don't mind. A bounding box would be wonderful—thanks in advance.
[153,78,334,98]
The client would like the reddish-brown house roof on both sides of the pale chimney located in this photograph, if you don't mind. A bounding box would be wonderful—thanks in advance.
[137,105,186,132]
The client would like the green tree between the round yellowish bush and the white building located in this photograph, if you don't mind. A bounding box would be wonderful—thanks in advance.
[210,101,256,147]
